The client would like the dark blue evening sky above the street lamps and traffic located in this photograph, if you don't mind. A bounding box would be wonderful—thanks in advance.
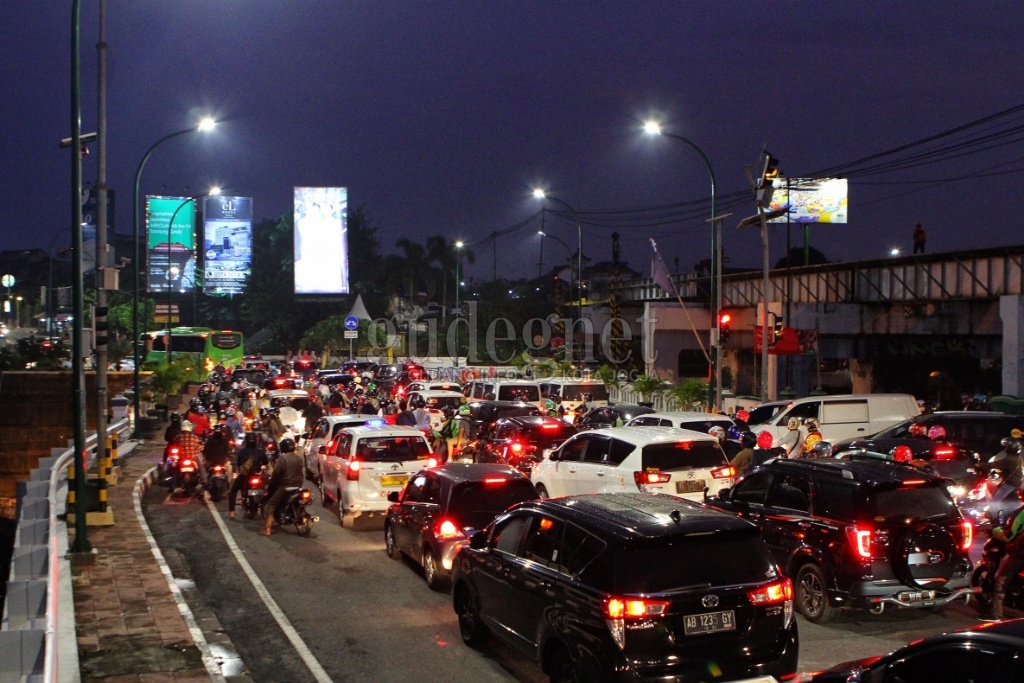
[0,0,1024,284]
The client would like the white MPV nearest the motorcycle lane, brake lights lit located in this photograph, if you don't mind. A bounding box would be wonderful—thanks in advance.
[321,425,437,528]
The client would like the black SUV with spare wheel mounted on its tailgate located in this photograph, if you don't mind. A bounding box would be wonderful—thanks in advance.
[708,457,973,624]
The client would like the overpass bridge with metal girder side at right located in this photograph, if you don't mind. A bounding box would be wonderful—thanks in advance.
[602,245,1024,408]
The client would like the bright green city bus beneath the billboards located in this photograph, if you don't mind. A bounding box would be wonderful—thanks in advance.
[139,328,245,381]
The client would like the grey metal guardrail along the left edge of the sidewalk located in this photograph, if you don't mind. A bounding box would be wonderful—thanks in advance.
[0,419,129,683]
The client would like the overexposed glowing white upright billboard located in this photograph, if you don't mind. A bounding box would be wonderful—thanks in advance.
[294,187,348,294]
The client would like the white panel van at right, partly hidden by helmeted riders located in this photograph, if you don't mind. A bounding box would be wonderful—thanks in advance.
[748,393,921,442]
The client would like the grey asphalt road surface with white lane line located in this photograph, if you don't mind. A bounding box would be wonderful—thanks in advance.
[143,475,1014,683]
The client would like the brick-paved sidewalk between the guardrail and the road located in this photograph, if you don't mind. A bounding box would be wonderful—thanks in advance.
[69,440,218,683]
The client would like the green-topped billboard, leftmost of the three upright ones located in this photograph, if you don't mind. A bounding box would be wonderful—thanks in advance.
[145,196,196,292]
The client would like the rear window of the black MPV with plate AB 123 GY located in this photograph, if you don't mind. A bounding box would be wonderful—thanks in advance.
[592,527,772,593]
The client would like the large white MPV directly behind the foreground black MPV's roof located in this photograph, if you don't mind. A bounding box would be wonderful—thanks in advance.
[530,427,736,502]
